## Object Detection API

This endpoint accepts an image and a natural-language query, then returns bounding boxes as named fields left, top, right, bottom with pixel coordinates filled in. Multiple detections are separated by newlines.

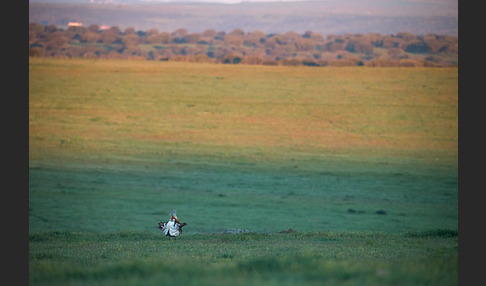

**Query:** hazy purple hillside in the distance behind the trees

left=29, top=0, right=458, bottom=36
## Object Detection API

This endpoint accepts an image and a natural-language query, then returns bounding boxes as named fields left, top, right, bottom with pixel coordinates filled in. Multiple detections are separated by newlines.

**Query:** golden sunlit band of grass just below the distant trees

left=29, top=59, right=458, bottom=162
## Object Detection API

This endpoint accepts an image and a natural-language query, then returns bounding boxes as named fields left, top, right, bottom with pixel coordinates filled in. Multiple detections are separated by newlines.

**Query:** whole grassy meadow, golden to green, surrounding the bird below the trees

left=29, top=58, right=458, bottom=285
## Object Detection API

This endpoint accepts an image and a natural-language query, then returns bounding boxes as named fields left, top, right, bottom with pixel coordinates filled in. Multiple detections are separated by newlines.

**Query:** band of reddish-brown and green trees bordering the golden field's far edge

left=29, top=23, right=458, bottom=67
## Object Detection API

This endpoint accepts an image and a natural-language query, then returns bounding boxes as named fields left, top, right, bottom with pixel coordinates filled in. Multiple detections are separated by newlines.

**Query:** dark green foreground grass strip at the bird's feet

left=29, top=230, right=457, bottom=285
